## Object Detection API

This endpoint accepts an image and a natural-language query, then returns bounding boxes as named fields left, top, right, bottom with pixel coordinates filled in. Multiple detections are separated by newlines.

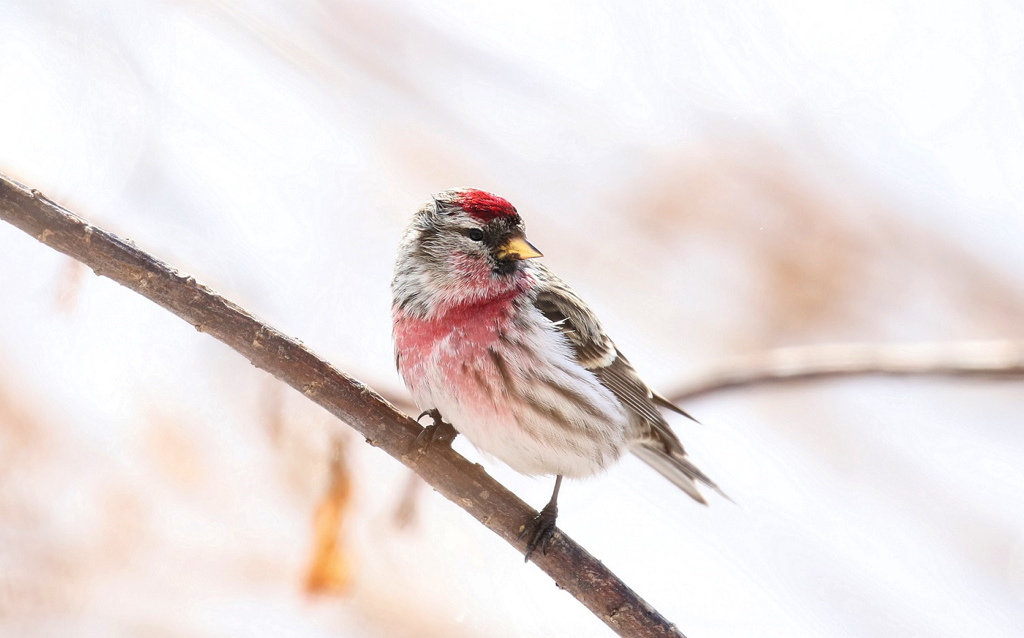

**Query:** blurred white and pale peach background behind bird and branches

left=0, top=0, right=1024, bottom=638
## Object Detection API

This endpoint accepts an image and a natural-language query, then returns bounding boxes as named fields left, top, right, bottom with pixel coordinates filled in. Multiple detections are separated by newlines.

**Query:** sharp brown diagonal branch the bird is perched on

left=0, top=175, right=682, bottom=638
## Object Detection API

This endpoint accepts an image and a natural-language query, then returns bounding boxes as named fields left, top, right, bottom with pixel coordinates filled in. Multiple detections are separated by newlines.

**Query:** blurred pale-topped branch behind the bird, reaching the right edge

left=669, top=340, right=1024, bottom=401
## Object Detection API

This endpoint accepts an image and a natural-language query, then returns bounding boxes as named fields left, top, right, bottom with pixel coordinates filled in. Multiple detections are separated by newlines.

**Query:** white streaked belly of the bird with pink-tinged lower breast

left=414, top=327, right=629, bottom=477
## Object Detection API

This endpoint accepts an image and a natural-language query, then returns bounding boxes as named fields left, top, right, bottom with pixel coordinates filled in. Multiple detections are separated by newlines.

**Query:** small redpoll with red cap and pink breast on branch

left=391, top=188, right=718, bottom=559
